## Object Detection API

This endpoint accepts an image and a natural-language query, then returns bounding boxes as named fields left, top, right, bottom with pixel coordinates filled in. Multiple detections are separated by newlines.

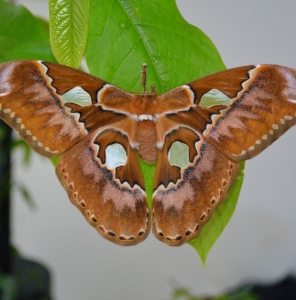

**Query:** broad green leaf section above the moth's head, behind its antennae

left=86, top=0, right=225, bottom=93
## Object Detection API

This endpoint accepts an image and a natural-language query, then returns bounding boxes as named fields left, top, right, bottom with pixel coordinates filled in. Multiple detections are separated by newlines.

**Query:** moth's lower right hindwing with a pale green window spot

left=152, top=123, right=239, bottom=246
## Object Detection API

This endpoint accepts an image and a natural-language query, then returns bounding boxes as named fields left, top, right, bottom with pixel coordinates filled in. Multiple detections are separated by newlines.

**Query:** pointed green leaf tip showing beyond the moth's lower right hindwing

left=189, top=162, right=245, bottom=265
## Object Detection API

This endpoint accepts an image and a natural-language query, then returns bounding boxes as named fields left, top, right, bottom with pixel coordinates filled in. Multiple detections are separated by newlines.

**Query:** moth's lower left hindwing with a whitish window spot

left=56, top=129, right=150, bottom=246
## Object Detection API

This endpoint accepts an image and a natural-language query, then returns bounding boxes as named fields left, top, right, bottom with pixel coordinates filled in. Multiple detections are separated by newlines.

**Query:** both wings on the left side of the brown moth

left=0, top=61, right=150, bottom=245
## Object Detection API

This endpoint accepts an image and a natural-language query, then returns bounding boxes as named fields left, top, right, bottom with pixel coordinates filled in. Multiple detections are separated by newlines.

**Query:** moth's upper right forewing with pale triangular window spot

left=189, top=65, right=296, bottom=161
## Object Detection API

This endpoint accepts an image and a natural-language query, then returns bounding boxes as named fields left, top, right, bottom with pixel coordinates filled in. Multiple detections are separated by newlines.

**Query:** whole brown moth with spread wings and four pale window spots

left=0, top=61, right=296, bottom=246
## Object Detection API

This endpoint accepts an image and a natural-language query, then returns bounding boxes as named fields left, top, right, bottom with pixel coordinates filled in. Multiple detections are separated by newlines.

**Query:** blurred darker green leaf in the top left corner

left=0, top=0, right=55, bottom=63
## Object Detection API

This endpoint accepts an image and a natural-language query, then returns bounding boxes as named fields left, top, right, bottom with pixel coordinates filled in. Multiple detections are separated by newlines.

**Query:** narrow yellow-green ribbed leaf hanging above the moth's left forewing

left=49, top=0, right=89, bottom=68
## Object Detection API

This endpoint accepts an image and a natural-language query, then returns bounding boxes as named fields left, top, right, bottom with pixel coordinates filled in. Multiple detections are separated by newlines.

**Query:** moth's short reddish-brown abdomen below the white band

left=137, top=120, right=157, bottom=163
